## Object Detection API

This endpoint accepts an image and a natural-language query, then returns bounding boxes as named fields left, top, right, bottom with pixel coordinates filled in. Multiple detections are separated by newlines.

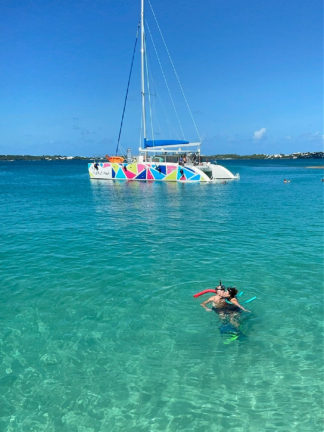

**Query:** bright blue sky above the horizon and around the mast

left=0, top=0, right=323, bottom=156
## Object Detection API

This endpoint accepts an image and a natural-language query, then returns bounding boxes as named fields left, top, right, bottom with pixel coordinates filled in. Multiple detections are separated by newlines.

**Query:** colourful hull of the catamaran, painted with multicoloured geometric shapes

left=88, top=162, right=239, bottom=183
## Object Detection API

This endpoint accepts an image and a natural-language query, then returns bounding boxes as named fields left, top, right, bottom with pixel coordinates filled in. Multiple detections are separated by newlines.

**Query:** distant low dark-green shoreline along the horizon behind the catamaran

left=0, top=152, right=324, bottom=161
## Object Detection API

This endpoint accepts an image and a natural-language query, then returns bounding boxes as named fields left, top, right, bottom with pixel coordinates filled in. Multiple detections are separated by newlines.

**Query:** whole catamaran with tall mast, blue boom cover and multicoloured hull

left=88, top=0, right=239, bottom=183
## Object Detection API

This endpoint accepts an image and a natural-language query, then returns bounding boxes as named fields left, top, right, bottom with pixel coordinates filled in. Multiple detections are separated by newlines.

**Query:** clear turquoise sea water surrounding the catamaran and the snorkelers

left=0, top=160, right=323, bottom=432
